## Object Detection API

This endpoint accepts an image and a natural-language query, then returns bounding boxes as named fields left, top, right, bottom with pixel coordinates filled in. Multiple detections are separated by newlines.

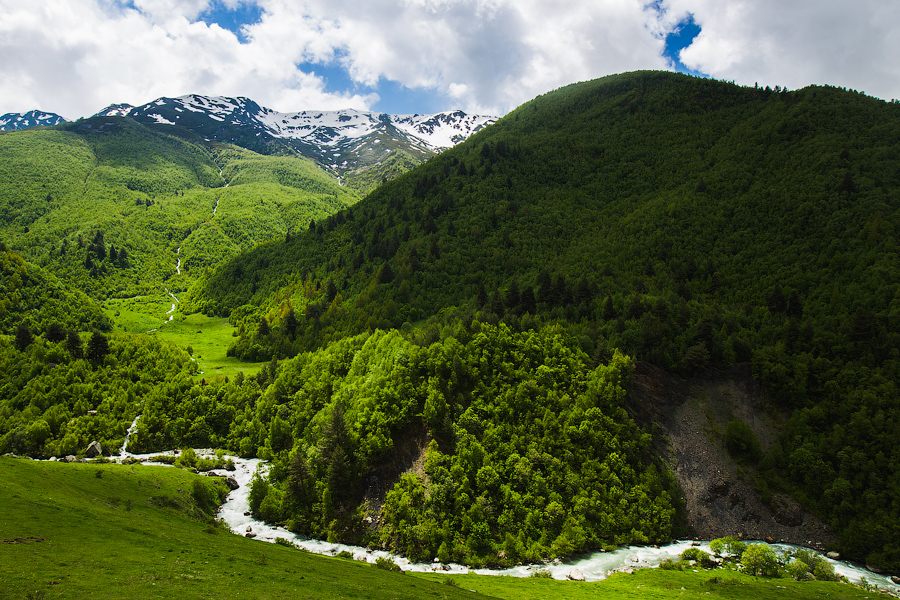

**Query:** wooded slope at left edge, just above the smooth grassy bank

left=0, top=322, right=197, bottom=458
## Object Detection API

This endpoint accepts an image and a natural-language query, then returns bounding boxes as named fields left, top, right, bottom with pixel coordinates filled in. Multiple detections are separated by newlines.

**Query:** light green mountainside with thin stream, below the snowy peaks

left=0, top=117, right=358, bottom=298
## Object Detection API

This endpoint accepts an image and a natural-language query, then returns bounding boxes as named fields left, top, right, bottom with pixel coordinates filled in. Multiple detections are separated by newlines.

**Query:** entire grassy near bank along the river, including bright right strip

left=0, top=457, right=886, bottom=600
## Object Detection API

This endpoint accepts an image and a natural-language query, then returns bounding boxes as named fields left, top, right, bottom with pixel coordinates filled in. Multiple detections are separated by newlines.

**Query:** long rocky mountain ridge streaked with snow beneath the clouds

left=97, top=94, right=496, bottom=188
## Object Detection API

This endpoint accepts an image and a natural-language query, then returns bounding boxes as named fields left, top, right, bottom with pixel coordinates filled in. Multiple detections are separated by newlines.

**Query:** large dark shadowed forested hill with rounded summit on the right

left=194, top=72, right=900, bottom=568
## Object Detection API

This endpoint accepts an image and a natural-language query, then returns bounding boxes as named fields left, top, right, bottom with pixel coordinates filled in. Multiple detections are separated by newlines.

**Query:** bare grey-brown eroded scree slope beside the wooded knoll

left=628, top=362, right=836, bottom=548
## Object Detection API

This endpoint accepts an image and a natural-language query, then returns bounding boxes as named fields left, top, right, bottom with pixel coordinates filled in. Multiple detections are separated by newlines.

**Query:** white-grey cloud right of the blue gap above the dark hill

left=665, top=0, right=900, bottom=99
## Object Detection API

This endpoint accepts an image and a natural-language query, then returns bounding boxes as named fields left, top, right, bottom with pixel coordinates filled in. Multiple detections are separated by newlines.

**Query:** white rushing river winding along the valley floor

left=105, top=448, right=900, bottom=597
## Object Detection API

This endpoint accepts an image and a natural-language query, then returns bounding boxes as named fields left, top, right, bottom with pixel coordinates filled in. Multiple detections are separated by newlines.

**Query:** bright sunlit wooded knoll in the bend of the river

left=98, top=321, right=676, bottom=564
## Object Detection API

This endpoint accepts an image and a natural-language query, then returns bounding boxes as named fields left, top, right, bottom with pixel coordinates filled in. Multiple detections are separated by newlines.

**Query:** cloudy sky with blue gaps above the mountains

left=0, top=0, right=900, bottom=119
